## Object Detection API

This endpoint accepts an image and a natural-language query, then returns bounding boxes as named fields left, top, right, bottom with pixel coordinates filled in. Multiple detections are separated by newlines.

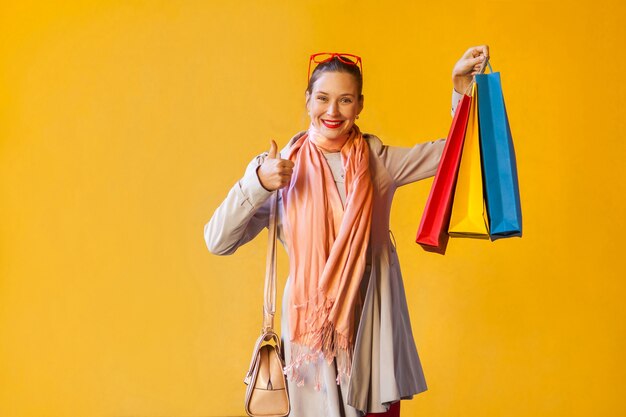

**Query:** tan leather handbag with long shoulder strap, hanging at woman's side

left=243, top=192, right=290, bottom=417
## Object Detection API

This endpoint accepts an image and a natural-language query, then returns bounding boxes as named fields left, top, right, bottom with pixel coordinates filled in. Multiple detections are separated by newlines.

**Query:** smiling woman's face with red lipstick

left=306, top=72, right=363, bottom=140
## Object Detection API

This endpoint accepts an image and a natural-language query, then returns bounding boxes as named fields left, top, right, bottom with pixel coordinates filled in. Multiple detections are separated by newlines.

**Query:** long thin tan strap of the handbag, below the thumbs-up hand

left=262, top=191, right=278, bottom=333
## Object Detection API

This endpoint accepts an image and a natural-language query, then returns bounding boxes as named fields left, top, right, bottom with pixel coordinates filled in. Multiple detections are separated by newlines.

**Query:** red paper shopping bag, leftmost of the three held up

left=415, top=95, right=472, bottom=253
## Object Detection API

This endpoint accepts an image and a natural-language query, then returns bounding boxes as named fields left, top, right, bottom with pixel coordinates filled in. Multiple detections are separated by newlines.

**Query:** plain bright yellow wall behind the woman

left=0, top=0, right=626, bottom=417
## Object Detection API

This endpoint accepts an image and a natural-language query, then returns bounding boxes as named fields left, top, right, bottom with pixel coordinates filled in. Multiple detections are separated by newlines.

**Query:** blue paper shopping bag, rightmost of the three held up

left=476, top=65, right=522, bottom=240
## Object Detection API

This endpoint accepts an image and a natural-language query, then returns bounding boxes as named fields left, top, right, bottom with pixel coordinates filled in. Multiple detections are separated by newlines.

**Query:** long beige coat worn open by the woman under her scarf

left=204, top=132, right=445, bottom=412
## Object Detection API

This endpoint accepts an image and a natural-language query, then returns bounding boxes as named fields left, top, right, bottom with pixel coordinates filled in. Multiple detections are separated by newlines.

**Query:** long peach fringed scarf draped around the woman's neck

left=283, top=125, right=373, bottom=389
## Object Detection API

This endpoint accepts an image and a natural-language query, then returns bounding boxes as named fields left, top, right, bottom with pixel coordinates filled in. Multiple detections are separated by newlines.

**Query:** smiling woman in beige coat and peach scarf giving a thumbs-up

left=204, top=45, right=489, bottom=417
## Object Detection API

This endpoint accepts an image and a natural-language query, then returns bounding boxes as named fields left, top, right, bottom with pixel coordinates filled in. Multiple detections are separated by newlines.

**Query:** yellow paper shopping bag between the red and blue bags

left=448, top=83, right=489, bottom=239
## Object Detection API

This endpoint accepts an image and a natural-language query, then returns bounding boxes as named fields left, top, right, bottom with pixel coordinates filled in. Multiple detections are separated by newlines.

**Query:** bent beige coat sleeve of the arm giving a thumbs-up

left=204, top=153, right=272, bottom=255
